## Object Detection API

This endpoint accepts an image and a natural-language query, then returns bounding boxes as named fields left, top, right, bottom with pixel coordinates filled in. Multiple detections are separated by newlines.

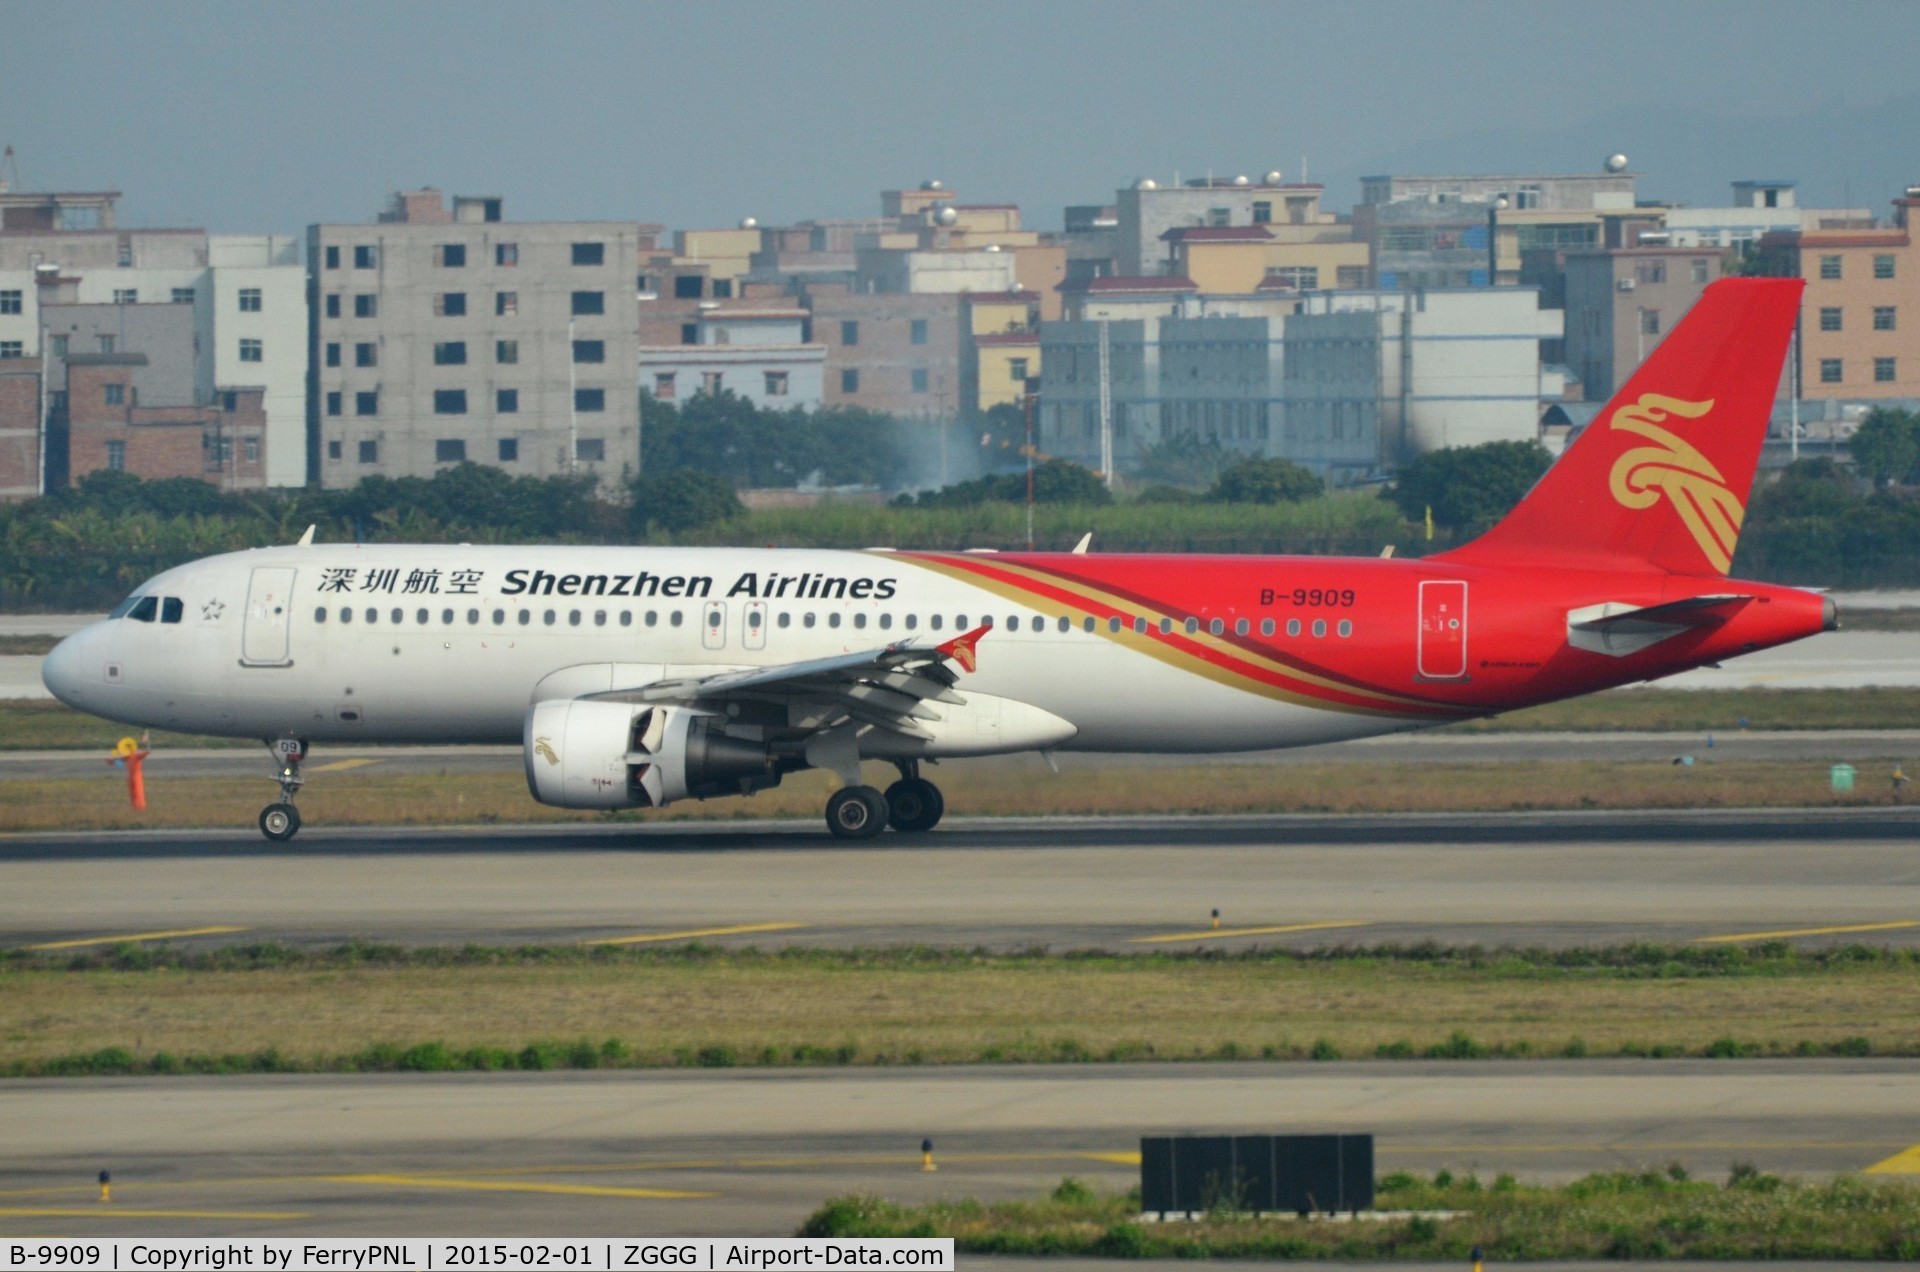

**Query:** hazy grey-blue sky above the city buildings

left=0, top=0, right=1920, bottom=232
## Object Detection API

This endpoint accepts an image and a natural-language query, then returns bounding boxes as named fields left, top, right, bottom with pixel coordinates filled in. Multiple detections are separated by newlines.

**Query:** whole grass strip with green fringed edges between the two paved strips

left=0, top=945, right=1920, bottom=1076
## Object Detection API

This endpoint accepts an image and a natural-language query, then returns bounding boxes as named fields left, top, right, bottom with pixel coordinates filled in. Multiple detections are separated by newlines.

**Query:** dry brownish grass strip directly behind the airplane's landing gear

left=0, top=761, right=1893, bottom=832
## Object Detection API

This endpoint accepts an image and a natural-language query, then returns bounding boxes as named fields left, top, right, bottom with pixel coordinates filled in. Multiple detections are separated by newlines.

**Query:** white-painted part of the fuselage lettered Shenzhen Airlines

left=44, top=546, right=1413, bottom=757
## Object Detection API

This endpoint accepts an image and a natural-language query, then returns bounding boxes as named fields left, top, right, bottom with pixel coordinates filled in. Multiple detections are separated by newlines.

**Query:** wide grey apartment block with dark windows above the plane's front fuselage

left=307, top=188, right=660, bottom=486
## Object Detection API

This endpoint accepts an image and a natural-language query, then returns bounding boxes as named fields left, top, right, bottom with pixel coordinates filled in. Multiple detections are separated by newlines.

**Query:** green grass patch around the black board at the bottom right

left=801, top=1164, right=1920, bottom=1262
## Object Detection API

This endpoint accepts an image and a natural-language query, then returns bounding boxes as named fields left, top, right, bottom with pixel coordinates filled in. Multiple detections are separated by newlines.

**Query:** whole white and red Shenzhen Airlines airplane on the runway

left=42, top=279, right=1837, bottom=840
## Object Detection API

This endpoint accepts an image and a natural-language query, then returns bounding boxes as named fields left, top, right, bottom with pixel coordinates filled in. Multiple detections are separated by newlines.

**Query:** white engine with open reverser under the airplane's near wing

left=524, top=697, right=780, bottom=809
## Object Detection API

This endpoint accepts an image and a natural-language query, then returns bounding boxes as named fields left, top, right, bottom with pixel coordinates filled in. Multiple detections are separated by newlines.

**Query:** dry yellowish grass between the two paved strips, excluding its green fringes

left=0, top=957, right=1920, bottom=1066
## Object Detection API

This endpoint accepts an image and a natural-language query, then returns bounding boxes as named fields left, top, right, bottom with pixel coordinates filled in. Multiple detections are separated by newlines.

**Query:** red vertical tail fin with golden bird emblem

left=1446, top=279, right=1805, bottom=575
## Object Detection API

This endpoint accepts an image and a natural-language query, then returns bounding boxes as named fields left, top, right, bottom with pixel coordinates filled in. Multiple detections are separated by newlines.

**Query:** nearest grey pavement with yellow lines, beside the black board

left=0, top=1061, right=1920, bottom=1235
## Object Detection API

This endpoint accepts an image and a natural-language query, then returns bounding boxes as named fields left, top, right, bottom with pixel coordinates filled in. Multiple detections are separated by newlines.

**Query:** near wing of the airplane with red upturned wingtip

left=589, top=626, right=991, bottom=740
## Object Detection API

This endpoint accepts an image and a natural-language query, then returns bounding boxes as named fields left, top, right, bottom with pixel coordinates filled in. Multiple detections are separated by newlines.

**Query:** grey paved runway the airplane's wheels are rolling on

left=0, top=809, right=1920, bottom=951
